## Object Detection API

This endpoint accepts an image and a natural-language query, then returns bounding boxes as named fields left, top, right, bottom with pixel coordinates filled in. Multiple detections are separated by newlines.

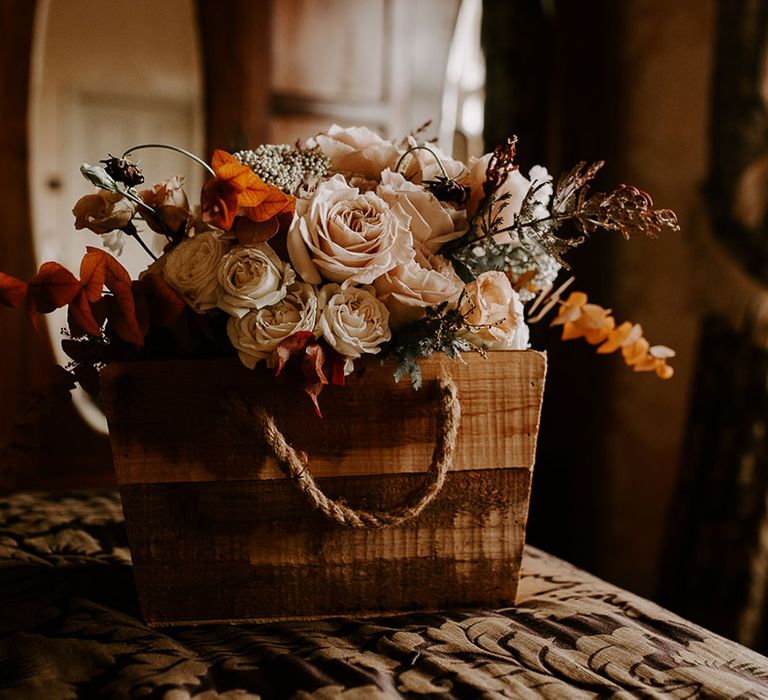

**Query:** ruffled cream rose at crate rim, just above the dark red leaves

left=227, top=282, right=319, bottom=369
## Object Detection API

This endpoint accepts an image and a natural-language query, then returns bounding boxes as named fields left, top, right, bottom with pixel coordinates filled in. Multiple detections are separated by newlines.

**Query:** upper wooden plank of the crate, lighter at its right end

left=101, top=350, right=546, bottom=484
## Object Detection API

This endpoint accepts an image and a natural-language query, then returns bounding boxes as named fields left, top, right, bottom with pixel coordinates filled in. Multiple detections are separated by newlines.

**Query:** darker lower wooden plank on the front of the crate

left=121, top=469, right=531, bottom=624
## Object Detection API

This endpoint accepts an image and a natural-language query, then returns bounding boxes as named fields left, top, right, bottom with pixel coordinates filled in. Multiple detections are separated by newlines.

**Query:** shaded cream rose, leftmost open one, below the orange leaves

left=162, top=230, right=232, bottom=313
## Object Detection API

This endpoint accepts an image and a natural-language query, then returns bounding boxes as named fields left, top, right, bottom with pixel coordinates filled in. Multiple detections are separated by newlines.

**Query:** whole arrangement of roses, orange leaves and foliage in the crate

left=0, top=126, right=678, bottom=413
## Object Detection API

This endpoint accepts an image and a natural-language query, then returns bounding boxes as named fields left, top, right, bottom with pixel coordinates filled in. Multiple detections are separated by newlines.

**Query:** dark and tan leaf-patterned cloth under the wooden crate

left=0, top=492, right=768, bottom=700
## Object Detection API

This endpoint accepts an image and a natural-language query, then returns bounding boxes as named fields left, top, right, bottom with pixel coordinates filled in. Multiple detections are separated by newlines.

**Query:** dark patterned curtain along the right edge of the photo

left=662, top=0, right=768, bottom=651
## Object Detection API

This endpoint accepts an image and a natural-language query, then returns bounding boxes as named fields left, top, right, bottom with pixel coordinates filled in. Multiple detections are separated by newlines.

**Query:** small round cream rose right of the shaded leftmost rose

left=217, top=243, right=296, bottom=317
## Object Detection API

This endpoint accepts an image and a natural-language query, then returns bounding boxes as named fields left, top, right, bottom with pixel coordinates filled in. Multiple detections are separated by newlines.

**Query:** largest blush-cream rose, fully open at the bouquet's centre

left=288, top=175, right=413, bottom=286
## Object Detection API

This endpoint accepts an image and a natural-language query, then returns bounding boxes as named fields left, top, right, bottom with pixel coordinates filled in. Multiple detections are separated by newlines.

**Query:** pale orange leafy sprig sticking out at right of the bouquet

left=552, top=292, right=675, bottom=379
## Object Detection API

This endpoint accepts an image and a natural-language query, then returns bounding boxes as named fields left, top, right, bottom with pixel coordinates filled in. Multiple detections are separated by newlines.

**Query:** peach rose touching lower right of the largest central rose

left=374, top=255, right=464, bottom=327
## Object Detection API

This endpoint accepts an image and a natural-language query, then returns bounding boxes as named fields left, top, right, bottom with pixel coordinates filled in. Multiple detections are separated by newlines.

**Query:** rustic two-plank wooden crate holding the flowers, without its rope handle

left=101, top=351, right=546, bottom=625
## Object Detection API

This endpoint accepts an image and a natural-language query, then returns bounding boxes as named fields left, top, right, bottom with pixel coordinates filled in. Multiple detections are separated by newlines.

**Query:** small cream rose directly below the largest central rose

left=319, top=284, right=392, bottom=359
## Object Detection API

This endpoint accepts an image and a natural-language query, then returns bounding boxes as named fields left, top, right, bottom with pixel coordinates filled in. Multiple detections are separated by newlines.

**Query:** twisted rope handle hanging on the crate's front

left=226, top=377, right=461, bottom=529
